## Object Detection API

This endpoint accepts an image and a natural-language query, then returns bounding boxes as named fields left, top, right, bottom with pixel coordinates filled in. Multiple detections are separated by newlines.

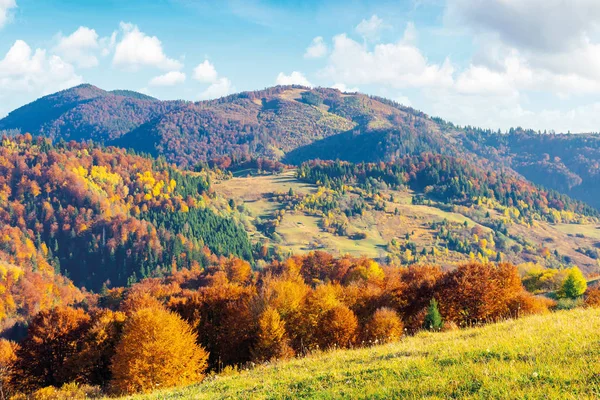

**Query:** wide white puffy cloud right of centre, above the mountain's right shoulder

left=321, top=34, right=454, bottom=88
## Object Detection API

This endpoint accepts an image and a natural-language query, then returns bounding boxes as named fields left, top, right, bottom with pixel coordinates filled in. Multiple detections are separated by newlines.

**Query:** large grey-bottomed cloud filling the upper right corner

left=445, top=0, right=600, bottom=96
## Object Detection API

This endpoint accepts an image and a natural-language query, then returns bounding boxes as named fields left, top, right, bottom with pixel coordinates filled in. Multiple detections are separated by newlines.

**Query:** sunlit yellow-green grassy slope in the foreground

left=122, top=309, right=600, bottom=400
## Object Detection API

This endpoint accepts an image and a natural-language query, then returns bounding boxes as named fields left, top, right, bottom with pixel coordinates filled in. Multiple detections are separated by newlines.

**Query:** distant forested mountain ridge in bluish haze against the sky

left=0, top=85, right=600, bottom=207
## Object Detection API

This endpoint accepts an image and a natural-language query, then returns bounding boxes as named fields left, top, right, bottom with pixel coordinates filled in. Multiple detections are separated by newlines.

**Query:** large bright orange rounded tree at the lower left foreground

left=111, top=308, right=208, bottom=393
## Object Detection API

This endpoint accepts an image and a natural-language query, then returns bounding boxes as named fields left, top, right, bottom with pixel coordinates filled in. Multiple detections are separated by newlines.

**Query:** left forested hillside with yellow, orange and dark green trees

left=0, top=135, right=252, bottom=291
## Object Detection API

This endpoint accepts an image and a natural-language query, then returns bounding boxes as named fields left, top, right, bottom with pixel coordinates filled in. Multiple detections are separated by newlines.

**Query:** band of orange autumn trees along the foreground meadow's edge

left=0, top=247, right=599, bottom=396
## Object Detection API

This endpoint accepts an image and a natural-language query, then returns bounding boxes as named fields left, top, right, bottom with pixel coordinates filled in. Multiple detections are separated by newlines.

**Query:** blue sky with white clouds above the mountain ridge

left=0, top=0, right=600, bottom=133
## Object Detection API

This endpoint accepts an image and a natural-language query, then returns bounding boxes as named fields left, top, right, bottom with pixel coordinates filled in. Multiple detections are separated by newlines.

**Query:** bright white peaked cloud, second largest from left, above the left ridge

left=113, top=22, right=183, bottom=71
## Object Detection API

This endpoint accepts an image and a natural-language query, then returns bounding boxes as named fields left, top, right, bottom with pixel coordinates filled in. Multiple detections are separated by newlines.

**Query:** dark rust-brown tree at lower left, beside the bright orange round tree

left=12, top=307, right=90, bottom=391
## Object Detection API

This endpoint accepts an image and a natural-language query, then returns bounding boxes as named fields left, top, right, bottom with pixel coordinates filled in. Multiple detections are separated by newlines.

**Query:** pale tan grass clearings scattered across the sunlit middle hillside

left=214, top=170, right=600, bottom=274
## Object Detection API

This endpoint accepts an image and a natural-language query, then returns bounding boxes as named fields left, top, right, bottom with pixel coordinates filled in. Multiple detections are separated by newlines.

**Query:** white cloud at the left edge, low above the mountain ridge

left=0, top=40, right=83, bottom=115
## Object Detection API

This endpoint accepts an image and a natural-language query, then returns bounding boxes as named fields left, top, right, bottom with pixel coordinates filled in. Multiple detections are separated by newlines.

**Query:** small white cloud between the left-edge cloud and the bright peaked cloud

left=54, top=26, right=100, bottom=68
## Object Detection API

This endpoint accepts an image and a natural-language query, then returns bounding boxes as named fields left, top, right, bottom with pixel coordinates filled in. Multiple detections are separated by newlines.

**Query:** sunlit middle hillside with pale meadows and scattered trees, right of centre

left=213, top=164, right=600, bottom=274
